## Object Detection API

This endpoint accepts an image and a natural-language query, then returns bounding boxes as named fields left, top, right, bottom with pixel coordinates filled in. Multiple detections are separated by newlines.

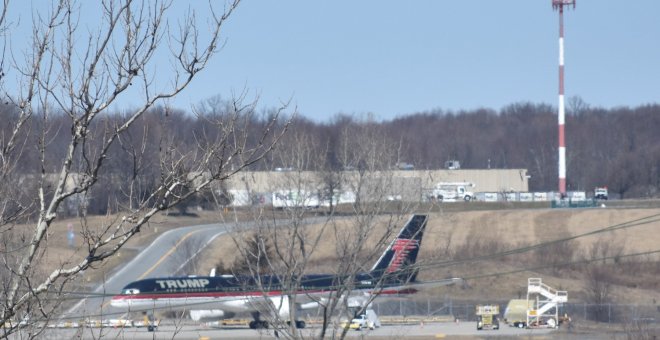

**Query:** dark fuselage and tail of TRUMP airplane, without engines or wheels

left=111, top=215, right=428, bottom=311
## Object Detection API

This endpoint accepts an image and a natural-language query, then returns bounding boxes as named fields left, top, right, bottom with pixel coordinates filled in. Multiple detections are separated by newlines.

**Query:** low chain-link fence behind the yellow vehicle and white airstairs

left=372, top=298, right=660, bottom=324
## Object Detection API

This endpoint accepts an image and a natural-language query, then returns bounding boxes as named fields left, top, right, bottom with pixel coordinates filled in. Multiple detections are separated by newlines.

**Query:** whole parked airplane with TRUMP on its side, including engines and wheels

left=111, top=214, right=460, bottom=329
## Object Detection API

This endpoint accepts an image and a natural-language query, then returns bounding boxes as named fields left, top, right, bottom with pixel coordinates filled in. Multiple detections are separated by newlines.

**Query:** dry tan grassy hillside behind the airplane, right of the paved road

left=200, top=208, right=660, bottom=304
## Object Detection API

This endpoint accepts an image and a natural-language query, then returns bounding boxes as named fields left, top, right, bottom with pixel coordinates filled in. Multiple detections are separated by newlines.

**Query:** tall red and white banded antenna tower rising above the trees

left=552, top=0, right=575, bottom=197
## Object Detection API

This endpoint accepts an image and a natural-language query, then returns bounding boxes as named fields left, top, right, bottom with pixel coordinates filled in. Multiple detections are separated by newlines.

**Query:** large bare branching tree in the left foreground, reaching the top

left=0, top=0, right=286, bottom=335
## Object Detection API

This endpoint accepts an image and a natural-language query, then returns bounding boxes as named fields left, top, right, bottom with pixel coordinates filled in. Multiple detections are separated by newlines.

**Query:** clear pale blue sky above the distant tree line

left=12, top=0, right=660, bottom=121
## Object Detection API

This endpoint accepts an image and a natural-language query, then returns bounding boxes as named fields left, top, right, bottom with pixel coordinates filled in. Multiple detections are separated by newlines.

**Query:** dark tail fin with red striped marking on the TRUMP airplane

left=371, top=215, right=428, bottom=283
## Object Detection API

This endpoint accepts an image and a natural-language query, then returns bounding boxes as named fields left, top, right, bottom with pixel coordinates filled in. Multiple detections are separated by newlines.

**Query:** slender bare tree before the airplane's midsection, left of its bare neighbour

left=248, top=129, right=331, bottom=338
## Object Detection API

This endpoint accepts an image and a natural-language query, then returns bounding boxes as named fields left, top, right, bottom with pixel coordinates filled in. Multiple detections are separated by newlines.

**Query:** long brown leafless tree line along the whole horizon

left=0, top=98, right=660, bottom=218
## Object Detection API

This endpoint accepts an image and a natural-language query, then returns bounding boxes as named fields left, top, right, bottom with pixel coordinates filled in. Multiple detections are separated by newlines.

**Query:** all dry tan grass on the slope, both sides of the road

left=25, top=201, right=660, bottom=303
